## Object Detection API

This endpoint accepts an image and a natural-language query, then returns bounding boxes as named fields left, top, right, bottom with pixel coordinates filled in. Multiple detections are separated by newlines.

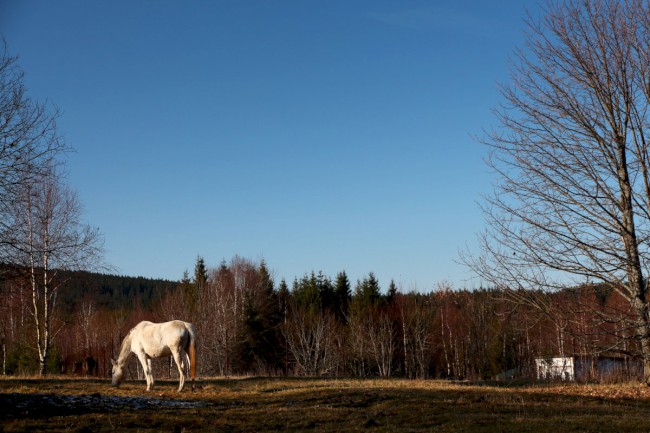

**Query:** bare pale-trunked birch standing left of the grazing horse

left=9, top=169, right=103, bottom=375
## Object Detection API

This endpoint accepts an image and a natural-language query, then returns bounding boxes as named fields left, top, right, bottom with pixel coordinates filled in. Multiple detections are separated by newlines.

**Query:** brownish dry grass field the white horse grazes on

left=0, top=378, right=650, bottom=433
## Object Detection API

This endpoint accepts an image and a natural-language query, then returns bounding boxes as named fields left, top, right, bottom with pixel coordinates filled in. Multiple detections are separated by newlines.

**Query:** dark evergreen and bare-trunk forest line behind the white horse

left=0, top=257, right=638, bottom=379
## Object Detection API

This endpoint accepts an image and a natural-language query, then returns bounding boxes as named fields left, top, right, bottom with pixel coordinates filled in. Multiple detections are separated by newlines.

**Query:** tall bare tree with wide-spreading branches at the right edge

left=468, top=0, right=650, bottom=385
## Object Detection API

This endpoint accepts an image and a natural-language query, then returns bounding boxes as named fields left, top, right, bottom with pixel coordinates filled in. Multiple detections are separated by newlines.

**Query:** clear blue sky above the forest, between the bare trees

left=0, top=0, right=538, bottom=291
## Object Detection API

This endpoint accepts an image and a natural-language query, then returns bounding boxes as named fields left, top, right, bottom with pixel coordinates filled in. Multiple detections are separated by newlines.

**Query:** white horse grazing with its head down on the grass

left=111, top=320, right=196, bottom=392
